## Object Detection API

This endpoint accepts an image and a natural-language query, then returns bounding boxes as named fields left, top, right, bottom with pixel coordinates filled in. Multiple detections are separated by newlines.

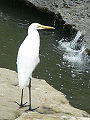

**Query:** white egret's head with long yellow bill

left=28, top=23, right=55, bottom=30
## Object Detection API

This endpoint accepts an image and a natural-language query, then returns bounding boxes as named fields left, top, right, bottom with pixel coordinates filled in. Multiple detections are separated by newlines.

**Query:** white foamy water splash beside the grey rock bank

left=58, top=31, right=89, bottom=70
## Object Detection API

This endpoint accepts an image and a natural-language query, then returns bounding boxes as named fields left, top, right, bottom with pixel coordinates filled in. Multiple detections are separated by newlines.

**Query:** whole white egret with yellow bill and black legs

left=17, top=23, right=54, bottom=111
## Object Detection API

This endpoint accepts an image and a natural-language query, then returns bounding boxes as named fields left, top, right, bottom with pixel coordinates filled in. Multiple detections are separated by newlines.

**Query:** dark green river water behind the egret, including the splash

left=0, top=0, right=90, bottom=114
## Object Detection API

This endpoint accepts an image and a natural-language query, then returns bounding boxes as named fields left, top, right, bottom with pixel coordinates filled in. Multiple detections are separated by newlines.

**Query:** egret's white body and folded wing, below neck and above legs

left=17, top=37, right=39, bottom=88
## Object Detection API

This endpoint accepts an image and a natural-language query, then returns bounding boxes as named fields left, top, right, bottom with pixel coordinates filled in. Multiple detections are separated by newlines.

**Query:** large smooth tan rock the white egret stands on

left=0, top=68, right=89, bottom=120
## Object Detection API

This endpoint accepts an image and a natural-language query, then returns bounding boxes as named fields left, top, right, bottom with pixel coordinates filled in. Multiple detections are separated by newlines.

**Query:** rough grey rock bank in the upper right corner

left=26, top=0, right=90, bottom=50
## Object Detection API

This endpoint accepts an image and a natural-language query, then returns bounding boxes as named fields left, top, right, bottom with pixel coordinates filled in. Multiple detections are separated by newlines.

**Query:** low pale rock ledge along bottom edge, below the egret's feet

left=16, top=112, right=90, bottom=120
